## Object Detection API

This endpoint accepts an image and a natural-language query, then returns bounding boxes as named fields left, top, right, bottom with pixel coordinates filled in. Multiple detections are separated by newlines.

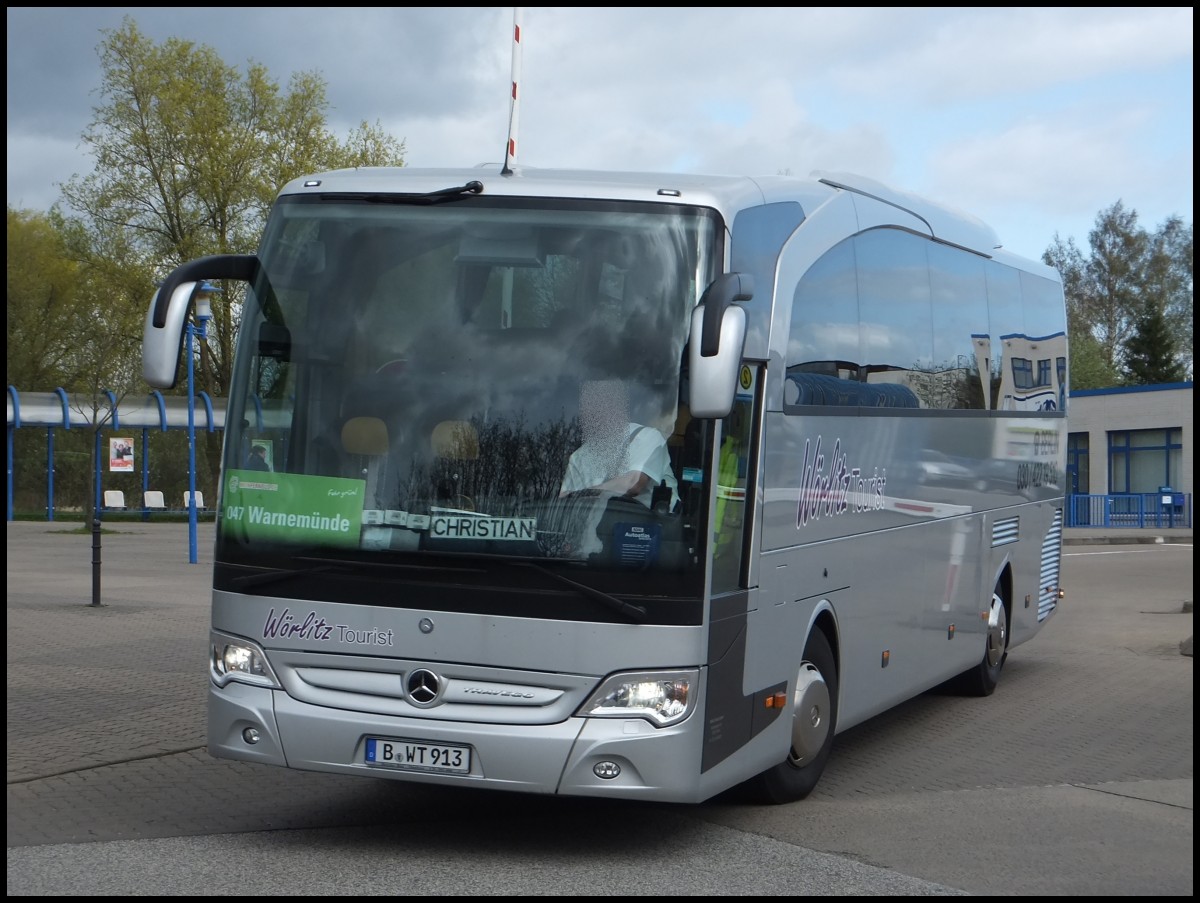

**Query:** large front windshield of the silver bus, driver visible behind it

left=217, top=190, right=721, bottom=600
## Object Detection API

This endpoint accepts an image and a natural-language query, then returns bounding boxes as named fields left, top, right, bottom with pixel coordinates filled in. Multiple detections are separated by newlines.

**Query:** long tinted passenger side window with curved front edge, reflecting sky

left=784, top=228, right=1067, bottom=412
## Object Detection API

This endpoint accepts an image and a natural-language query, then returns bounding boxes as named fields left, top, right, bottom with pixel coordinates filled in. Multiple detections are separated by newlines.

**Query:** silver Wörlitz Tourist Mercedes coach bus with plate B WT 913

left=144, top=168, right=1067, bottom=802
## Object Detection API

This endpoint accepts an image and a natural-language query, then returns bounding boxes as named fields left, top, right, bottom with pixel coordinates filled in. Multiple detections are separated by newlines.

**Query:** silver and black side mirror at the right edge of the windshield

left=688, top=273, right=754, bottom=418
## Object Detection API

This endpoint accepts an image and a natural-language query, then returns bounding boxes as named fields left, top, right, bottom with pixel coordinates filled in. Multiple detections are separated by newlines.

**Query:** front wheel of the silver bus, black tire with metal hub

left=748, top=629, right=838, bottom=805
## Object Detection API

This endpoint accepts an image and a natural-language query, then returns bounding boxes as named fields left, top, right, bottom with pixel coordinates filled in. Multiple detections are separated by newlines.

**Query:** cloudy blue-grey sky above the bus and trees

left=7, top=6, right=1193, bottom=257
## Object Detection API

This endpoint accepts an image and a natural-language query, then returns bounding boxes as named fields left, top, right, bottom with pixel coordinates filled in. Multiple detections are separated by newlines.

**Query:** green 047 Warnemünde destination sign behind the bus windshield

left=221, top=471, right=366, bottom=546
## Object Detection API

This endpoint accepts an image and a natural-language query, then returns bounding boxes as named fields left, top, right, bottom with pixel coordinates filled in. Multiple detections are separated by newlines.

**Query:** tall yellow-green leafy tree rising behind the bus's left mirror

left=62, top=17, right=404, bottom=501
